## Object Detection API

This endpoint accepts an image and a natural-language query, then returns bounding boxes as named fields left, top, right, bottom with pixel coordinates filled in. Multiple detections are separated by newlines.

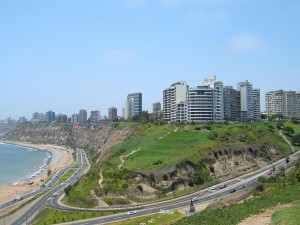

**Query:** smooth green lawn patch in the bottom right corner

left=272, top=203, right=300, bottom=225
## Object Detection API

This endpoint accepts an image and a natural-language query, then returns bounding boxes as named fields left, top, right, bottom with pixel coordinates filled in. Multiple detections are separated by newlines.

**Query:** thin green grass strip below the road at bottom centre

left=106, top=211, right=183, bottom=225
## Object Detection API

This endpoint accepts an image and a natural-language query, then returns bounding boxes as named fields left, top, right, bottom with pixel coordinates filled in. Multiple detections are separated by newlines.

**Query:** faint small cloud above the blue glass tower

left=104, top=50, right=136, bottom=64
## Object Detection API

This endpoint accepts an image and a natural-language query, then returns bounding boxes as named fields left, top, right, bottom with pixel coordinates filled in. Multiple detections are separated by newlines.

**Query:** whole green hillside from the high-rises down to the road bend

left=65, top=123, right=290, bottom=207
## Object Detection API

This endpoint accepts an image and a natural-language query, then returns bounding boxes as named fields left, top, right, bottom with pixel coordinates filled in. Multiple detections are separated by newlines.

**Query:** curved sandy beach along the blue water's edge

left=0, top=142, right=74, bottom=207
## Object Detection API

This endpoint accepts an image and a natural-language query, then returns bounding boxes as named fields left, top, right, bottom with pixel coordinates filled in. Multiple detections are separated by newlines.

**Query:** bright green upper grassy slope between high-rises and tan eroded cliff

left=104, top=124, right=289, bottom=171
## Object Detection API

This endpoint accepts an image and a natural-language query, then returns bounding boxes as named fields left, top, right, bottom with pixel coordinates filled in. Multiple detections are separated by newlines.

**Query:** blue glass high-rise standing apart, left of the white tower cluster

left=125, top=93, right=143, bottom=119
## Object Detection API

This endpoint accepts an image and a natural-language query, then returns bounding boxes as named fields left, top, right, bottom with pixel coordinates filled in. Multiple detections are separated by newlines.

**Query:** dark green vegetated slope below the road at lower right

left=176, top=156, right=300, bottom=225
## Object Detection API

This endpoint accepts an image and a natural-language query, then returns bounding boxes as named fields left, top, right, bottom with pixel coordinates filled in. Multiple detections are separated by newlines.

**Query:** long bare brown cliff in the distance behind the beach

left=2, top=124, right=133, bottom=160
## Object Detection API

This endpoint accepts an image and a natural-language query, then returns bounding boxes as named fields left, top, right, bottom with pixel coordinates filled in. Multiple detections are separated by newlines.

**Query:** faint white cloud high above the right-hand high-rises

left=226, top=33, right=267, bottom=53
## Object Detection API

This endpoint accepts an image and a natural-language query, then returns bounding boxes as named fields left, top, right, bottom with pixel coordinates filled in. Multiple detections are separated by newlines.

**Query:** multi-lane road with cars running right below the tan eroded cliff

left=46, top=149, right=300, bottom=225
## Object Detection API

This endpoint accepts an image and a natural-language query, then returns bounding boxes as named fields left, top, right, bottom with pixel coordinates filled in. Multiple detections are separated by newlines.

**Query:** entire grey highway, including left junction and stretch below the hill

left=2, top=134, right=300, bottom=225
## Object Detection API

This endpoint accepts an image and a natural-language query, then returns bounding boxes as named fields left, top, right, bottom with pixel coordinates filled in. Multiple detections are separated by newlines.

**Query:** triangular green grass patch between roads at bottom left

left=32, top=209, right=112, bottom=225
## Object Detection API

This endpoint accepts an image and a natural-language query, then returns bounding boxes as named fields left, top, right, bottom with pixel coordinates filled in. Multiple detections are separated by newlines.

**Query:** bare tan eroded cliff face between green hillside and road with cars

left=122, top=144, right=280, bottom=198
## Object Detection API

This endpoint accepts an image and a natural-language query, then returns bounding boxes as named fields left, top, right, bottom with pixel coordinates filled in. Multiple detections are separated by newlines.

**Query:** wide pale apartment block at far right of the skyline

left=265, top=90, right=300, bottom=118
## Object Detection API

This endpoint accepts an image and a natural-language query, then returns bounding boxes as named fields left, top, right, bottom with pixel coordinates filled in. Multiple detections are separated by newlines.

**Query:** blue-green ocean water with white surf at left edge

left=0, top=143, right=51, bottom=186
